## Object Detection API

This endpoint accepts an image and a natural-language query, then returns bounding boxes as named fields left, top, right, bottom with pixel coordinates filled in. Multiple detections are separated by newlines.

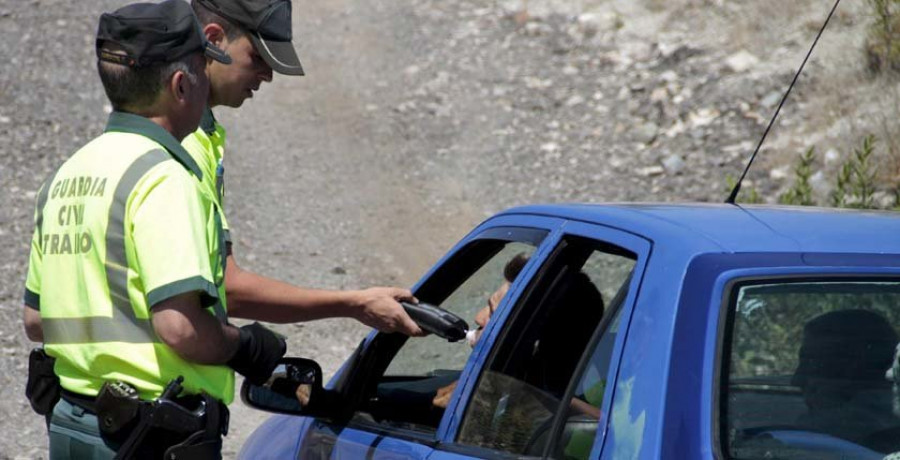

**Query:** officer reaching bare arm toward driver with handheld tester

left=183, top=0, right=422, bottom=336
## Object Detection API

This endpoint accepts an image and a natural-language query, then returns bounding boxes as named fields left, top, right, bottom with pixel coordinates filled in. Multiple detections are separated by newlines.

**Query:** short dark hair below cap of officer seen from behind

left=97, top=43, right=205, bottom=113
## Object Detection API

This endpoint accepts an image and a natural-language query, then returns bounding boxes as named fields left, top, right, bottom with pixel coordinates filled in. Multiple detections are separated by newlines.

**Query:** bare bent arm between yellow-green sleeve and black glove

left=151, top=292, right=240, bottom=364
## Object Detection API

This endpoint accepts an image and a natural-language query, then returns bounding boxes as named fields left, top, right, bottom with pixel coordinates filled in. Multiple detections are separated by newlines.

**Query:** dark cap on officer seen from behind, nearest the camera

left=96, top=0, right=231, bottom=67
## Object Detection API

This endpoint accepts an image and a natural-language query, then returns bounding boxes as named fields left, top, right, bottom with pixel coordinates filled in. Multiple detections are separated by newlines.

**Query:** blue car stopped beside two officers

left=240, top=204, right=900, bottom=460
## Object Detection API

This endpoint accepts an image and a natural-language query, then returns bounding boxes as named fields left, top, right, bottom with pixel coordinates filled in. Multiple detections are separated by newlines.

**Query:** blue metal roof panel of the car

left=501, top=203, right=900, bottom=254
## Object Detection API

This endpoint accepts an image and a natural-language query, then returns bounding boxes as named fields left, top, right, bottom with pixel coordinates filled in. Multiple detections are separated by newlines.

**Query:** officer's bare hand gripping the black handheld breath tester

left=355, top=287, right=425, bottom=337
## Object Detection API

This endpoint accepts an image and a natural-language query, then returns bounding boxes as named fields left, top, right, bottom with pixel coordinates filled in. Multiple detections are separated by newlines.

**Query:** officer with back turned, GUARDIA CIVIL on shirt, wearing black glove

left=24, top=0, right=285, bottom=458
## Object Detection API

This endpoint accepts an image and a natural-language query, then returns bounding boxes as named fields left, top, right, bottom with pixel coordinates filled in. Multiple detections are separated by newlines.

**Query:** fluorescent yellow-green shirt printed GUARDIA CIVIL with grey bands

left=25, top=112, right=234, bottom=403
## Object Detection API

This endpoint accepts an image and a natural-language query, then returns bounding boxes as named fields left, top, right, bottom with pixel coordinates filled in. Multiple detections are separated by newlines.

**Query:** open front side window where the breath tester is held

left=354, top=229, right=546, bottom=436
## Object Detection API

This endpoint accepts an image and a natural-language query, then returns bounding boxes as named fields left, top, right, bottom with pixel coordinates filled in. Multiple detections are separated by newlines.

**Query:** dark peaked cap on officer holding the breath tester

left=196, top=0, right=304, bottom=75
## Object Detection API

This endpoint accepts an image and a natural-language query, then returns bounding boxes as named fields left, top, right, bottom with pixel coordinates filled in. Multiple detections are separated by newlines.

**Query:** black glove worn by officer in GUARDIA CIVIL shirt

left=228, top=323, right=287, bottom=385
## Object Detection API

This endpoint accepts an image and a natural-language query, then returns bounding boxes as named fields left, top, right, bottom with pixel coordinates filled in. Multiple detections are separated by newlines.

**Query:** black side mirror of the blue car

left=241, top=357, right=339, bottom=418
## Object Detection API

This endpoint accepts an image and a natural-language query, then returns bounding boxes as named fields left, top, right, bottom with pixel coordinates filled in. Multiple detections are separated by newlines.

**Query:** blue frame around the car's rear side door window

left=435, top=220, right=653, bottom=458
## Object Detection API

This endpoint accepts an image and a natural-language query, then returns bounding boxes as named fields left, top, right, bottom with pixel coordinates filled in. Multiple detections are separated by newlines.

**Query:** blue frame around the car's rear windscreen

left=701, top=264, right=900, bottom=460
